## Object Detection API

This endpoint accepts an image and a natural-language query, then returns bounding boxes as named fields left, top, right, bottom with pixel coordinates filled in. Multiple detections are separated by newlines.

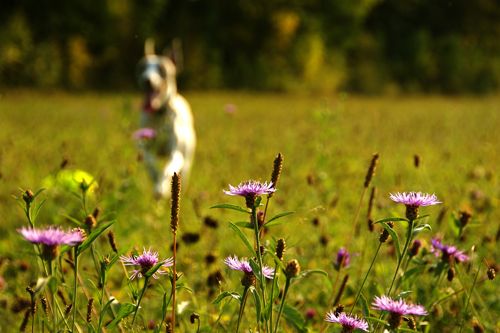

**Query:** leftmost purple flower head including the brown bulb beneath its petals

left=17, top=226, right=83, bottom=260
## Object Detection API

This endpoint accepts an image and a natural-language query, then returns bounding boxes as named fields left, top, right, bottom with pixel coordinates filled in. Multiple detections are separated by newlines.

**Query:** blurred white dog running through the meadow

left=134, top=39, right=196, bottom=197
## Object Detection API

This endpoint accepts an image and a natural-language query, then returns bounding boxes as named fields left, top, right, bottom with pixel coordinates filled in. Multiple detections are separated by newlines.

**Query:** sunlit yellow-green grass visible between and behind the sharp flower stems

left=0, top=91, right=500, bottom=332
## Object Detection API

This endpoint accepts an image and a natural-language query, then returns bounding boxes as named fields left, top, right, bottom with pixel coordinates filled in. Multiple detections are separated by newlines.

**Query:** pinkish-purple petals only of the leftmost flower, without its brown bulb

left=17, top=226, right=83, bottom=246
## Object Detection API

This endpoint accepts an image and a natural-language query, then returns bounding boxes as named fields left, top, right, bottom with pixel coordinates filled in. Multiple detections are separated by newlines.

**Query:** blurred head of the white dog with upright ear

left=137, top=39, right=181, bottom=114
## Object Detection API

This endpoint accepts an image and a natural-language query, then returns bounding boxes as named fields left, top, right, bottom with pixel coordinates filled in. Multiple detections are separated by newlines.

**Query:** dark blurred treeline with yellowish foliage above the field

left=0, top=0, right=500, bottom=94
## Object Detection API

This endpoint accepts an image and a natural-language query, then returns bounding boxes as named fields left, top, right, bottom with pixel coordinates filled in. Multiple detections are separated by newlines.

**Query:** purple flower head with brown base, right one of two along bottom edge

left=372, top=295, right=427, bottom=329
